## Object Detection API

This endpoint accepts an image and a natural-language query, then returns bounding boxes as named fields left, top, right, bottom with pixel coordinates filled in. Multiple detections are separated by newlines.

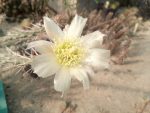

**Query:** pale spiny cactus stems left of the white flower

left=0, top=23, right=43, bottom=73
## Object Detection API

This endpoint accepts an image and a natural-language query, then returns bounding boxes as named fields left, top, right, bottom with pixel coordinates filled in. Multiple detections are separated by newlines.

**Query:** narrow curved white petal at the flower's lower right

left=70, top=67, right=90, bottom=89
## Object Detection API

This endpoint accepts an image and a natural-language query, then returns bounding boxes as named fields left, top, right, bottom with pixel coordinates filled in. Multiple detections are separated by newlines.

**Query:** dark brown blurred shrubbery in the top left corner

left=0, top=0, right=56, bottom=21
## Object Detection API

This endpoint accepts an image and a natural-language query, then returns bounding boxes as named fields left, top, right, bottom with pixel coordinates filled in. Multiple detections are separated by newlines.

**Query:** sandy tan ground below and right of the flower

left=0, top=19, right=150, bottom=113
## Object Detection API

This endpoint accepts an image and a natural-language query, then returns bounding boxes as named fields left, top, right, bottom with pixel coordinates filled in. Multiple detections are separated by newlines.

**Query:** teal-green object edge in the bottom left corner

left=0, top=81, right=8, bottom=113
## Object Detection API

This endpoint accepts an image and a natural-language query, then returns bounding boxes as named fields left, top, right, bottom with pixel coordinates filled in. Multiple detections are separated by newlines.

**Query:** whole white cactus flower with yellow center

left=28, top=15, right=110, bottom=92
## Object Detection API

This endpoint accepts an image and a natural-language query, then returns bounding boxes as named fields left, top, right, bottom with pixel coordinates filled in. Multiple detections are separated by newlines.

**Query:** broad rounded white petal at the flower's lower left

left=31, top=54, right=60, bottom=78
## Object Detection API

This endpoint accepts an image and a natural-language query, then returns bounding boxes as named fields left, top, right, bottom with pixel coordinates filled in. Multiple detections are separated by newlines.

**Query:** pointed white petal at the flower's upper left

left=44, top=17, right=64, bottom=41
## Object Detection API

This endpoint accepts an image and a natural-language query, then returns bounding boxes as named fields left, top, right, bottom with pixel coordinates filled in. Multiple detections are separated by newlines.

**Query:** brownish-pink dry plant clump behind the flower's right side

left=85, top=8, right=140, bottom=64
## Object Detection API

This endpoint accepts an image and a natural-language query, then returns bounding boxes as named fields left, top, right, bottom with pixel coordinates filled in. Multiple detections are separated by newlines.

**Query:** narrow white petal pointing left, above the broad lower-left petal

left=27, top=40, right=53, bottom=54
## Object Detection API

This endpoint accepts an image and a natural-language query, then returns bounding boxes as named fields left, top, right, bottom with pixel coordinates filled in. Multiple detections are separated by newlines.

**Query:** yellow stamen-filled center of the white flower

left=54, top=40, right=84, bottom=67
